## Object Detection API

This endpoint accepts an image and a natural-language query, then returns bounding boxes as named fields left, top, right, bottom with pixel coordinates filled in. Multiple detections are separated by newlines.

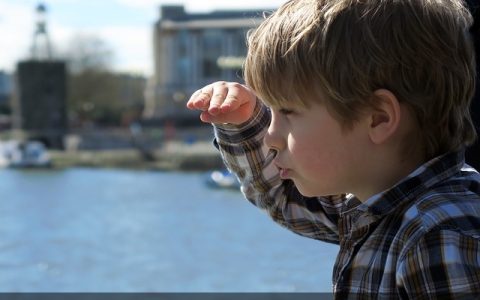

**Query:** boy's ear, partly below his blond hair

left=368, top=89, right=402, bottom=144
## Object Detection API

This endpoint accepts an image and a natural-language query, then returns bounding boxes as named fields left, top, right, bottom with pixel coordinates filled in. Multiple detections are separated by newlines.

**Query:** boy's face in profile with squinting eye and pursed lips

left=265, top=104, right=368, bottom=196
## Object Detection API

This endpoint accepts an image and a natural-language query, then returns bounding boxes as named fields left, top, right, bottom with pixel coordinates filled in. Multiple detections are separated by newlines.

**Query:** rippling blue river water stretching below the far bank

left=0, top=168, right=338, bottom=292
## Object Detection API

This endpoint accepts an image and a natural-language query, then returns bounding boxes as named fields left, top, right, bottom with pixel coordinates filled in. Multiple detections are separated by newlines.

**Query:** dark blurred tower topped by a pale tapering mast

left=12, top=3, right=68, bottom=149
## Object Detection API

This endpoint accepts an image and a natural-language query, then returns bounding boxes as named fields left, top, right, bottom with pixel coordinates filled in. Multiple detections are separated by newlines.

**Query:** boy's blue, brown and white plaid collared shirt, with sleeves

left=214, top=103, right=480, bottom=299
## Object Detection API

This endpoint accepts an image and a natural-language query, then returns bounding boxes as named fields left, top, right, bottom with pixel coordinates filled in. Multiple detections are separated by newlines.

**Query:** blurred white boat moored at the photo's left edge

left=0, top=140, right=52, bottom=168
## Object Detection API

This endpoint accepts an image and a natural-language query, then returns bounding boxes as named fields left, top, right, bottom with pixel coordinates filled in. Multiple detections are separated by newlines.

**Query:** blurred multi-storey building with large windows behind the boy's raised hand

left=144, top=5, right=272, bottom=122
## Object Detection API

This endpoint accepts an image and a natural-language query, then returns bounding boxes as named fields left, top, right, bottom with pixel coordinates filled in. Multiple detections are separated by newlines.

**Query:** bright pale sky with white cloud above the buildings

left=0, top=0, right=285, bottom=76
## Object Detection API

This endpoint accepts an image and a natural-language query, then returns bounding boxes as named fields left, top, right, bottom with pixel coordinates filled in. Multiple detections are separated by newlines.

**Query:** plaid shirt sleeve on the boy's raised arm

left=214, top=101, right=344, bottom=244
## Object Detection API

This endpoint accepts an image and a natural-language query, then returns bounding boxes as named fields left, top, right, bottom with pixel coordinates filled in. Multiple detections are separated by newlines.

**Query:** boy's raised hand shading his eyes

left=187, top=81, right=257, bottom=125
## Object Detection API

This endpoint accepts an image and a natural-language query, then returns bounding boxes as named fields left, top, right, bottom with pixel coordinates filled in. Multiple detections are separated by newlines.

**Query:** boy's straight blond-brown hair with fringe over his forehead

left=244, top=0, right=476, bottom=157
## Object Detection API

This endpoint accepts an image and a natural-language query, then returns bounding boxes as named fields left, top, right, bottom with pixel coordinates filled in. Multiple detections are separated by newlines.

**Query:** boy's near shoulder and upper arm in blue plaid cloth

left=396, top=171, right=480, bottom=299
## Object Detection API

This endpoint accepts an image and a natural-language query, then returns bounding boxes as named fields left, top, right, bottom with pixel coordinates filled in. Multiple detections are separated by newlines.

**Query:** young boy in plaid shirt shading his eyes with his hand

left=187, top=0, right=480, bottom=299
